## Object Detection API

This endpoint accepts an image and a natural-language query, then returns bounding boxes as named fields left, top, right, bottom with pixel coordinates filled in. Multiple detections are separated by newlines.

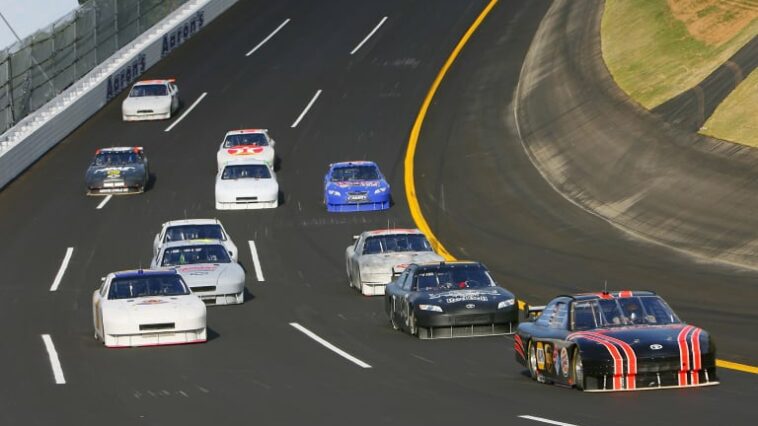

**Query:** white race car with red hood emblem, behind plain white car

left=216, top=129, right=276, bottom=170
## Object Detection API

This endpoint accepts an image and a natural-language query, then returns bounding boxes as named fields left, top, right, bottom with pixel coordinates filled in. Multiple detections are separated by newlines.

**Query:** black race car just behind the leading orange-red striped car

left=384, top=261, right=519, bottom=339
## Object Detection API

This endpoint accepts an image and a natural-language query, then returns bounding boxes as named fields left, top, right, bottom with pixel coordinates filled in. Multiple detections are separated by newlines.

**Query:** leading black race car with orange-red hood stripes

left=513, top=291, right=718, bottom=392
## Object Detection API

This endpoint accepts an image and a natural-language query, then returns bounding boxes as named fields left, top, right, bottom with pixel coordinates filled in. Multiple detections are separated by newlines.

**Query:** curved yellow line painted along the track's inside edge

left=404, top=0, right=758, bottom=374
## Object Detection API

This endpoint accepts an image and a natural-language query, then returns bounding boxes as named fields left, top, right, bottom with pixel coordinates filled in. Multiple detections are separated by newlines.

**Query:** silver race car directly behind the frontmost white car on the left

left=150, top=240, right=245, bottom=305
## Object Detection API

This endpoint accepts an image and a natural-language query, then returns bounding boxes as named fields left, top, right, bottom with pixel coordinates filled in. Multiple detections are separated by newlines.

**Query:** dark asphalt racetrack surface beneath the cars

left=0, top=0, right=757, bottom=425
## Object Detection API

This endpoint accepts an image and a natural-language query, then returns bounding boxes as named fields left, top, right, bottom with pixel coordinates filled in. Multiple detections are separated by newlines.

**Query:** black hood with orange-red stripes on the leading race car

left=569, top=324, right=714, bottom=358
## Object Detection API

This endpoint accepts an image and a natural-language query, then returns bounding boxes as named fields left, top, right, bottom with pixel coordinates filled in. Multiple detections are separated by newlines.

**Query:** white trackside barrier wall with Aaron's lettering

left=0, top=0, right=238, bottom=189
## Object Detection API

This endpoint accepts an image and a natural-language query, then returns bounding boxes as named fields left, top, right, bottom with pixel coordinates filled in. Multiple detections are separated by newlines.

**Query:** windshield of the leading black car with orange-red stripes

left=572, top=296, right=681, bottom=330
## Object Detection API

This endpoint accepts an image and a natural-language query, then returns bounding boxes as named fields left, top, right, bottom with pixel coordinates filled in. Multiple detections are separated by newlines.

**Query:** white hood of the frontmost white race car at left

left=103, top=295, right=205, bottom=324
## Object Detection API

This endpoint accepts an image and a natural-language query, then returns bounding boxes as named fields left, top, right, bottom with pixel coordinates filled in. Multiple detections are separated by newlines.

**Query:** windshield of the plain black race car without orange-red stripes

left=413, top=265, right=495, bottom=291
